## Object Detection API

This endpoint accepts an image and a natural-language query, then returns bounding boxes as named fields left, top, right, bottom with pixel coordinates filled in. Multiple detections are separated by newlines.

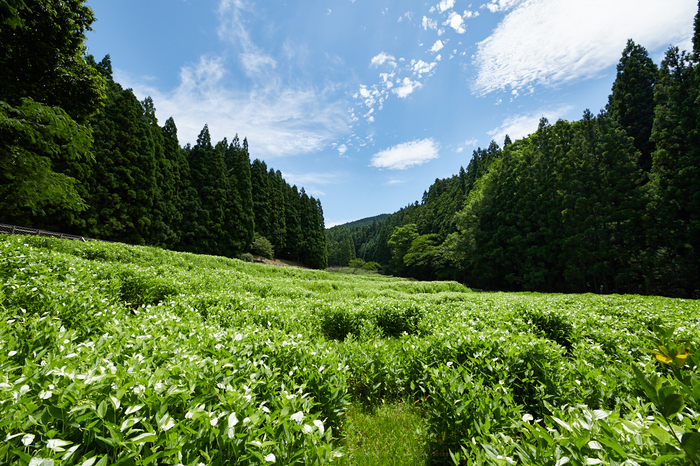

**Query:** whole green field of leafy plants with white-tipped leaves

left=0, top=235, right=700, bottom=466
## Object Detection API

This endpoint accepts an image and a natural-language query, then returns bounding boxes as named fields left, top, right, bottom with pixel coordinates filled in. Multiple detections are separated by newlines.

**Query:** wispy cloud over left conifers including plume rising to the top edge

left=119, top=0, right=349, bottom=158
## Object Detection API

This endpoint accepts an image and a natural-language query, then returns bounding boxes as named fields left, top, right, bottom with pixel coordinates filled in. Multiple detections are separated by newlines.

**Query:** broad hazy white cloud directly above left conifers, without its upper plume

left=120, top=58, right=348, bottom=158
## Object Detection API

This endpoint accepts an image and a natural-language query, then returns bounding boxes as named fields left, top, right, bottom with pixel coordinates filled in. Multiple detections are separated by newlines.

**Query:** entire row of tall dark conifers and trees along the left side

left=0, top=0, right=327, bottom=268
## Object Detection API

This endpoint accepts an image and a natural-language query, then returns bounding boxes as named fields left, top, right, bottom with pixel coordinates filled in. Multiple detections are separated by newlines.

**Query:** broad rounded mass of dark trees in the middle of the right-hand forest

left=457, top=112, right=643, bottom=291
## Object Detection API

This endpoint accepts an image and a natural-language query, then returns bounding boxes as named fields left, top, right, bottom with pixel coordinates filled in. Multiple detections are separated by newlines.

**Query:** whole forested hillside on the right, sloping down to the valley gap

left=327, top=10, right=700, bottom=297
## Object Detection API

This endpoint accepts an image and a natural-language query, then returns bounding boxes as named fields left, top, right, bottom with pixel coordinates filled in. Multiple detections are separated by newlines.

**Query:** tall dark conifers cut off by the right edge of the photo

left=649, top=45, right=700, bottom=297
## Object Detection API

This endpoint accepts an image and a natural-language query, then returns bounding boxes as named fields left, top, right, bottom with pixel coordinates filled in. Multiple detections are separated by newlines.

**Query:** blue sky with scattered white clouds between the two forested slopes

left=87, top=0, right=697, bottom=226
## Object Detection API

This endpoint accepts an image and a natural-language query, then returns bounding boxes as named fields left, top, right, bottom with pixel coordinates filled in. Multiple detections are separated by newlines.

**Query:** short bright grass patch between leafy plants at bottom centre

left=343, top=403, right=430, bottom=466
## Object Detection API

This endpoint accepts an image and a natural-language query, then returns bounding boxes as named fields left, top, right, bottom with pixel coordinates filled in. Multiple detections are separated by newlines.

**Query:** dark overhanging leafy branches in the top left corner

left=0, top=0, right=104, bottom=124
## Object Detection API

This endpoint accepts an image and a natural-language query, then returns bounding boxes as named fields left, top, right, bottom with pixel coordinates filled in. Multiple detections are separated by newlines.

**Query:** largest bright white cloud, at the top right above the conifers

left=473, top=0, right=697, bottom=94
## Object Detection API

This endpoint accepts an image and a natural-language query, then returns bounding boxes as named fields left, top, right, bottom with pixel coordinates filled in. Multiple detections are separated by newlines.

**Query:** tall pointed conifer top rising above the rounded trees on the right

left=606, top=40, right=658, bottom=172
